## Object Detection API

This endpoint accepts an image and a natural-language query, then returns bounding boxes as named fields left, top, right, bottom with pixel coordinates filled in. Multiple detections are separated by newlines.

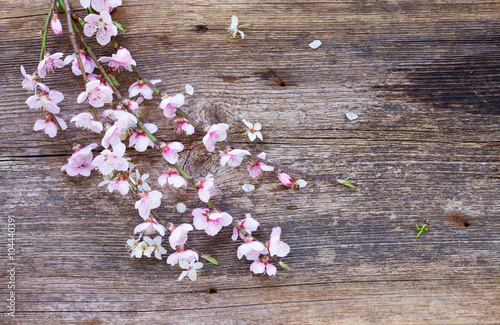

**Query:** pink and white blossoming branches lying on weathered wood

left=21, top=0, right=354, bottom=281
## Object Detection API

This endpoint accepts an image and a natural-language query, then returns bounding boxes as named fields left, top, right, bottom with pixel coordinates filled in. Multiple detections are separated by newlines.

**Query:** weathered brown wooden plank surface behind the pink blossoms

left=0, top=0, right=500, bottom=324
